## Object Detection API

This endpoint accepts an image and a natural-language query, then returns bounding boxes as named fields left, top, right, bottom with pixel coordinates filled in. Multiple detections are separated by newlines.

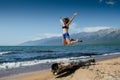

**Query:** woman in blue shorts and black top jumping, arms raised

left=60, top=13, right=82, bottom=46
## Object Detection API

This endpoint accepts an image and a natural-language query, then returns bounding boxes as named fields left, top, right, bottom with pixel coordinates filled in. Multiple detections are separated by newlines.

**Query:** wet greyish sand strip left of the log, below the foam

left=0, top=64, right=51, bottom=80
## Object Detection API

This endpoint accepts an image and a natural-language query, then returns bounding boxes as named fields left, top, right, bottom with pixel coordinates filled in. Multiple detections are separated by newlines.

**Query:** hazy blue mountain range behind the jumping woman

left=20, top=28, right=120, bottom=46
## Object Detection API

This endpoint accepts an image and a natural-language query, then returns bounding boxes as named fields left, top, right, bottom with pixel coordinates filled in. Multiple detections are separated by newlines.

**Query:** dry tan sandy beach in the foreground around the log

left=7, top=57, right=120, bottom=80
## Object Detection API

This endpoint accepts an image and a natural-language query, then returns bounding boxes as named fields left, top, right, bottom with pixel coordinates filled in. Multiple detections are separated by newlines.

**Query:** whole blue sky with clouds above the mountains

left=0, top=0, right=120, bottom=45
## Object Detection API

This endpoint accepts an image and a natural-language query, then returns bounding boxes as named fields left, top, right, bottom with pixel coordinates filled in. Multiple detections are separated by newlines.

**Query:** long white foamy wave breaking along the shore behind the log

left=0, top=56, right=88, bottom=70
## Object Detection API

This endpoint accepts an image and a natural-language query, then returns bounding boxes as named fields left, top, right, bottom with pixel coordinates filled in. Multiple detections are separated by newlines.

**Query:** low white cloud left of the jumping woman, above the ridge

left=31, top=33, right=61, bottom=41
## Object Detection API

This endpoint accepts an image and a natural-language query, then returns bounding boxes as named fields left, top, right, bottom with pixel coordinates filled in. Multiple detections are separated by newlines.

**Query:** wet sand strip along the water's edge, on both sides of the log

left=0, top=52, right=120, bottom=80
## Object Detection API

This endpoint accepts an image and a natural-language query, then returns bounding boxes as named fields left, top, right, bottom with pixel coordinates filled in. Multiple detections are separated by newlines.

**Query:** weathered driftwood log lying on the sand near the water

left=51, top=58, right=95, bottom=75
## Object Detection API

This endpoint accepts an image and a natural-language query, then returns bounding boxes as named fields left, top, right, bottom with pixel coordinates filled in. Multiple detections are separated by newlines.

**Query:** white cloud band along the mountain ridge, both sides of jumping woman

left=31, top=23, right=111, bottom=41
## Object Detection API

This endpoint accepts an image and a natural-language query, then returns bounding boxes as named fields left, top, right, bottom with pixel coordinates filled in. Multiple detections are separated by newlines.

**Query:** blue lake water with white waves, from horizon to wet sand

left=0, top=45, right=120, bottom=70
